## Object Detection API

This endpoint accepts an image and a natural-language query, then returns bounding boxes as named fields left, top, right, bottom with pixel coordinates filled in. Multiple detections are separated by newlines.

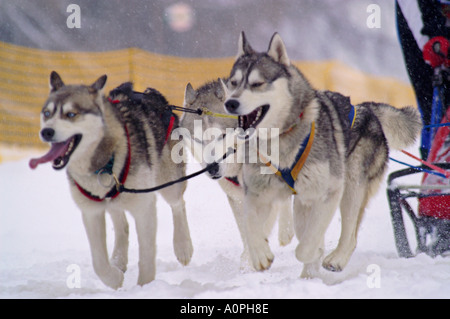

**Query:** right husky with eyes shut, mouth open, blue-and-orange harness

left=221, top=33, right=421, bottom=277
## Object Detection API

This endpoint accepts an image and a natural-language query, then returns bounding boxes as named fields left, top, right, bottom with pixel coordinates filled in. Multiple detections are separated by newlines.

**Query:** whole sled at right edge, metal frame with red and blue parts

left=387, top=65, right=450, bottom=258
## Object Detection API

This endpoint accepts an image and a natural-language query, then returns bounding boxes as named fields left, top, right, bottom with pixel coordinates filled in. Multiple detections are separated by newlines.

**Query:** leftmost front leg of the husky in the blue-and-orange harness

left=244, top=195, right=274, bottom=271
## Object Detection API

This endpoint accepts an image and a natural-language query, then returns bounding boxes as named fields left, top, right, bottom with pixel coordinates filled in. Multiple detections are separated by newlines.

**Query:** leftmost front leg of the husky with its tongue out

left=82, top=210, right=123, bottom=289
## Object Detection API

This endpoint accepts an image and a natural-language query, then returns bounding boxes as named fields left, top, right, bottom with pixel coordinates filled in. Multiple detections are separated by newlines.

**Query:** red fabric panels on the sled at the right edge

left=419, top=107, right=450, bottom=219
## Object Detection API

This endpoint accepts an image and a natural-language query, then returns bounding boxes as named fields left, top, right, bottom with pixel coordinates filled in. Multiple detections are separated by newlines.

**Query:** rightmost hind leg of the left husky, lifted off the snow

left=160, top=182, right=194, bottom=266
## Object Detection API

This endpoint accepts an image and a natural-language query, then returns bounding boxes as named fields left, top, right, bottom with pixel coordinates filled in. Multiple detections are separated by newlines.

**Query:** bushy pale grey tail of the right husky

left=362, top=103, right=422, bottom=150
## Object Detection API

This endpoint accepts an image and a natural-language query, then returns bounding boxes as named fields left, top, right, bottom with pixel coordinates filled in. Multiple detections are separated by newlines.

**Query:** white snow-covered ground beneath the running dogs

left=0, top=148, right=450, bottom=298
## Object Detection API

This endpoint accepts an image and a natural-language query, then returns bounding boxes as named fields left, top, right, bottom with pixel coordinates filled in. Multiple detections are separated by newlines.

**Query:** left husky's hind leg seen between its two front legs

left=109, top=210, right=129, bottom=272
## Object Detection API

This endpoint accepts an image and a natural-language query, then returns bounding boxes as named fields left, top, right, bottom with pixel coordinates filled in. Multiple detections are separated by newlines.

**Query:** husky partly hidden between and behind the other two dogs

left=180, top=79, right=294, bottom=266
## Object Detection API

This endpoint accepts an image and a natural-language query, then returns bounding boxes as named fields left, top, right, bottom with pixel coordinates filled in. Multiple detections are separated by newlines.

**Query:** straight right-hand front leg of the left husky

left=130, top=194, right=157, bottom=286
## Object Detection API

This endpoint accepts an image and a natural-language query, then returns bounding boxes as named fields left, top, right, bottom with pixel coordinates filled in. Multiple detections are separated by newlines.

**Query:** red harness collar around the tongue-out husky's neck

left=73, top=125, right=131, bottom=202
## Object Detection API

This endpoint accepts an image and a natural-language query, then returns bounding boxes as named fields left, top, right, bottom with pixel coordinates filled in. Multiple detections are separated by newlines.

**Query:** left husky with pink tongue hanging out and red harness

left=30, top=72, right=193, bottom=289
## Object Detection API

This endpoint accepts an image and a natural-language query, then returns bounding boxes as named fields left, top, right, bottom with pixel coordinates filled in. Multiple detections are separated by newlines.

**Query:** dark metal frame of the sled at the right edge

left=387, top=163, right=450, bottom=258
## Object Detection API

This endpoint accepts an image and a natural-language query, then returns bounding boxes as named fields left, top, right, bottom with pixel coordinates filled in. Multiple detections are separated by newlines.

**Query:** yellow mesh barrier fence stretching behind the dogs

left=0, top=42, right=415, bottom=147
